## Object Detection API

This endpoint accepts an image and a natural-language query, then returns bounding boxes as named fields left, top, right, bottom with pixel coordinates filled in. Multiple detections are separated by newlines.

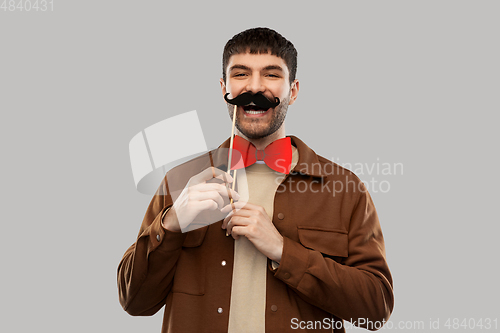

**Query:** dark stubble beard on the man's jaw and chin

left=226, top=94, right=290, bottom=139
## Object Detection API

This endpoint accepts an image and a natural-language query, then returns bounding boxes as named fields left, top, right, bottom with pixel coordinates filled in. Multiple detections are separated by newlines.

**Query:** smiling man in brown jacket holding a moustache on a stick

left=118, top=28, right=394, bottom=333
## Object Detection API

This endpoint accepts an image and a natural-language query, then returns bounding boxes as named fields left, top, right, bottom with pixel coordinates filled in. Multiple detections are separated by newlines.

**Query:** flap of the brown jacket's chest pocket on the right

left=297, top=226, right=349, bottom=258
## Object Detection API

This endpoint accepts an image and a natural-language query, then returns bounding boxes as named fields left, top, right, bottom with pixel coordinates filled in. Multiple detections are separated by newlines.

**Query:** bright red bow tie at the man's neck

left=231, top=135, right=292, bottom=174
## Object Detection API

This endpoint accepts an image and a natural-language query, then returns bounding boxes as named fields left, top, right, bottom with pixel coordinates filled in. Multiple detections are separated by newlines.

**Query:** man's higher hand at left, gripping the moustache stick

left=162, top=167, right=239, bottom=231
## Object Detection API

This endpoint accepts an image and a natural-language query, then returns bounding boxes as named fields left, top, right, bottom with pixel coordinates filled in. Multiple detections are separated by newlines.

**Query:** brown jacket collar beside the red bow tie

left=213, top=135, right=326, bottom=177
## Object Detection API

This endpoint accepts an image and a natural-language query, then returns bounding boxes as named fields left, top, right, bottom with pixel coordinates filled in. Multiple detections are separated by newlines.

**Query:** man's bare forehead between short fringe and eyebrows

left=227, top=52, right=288, bottom=73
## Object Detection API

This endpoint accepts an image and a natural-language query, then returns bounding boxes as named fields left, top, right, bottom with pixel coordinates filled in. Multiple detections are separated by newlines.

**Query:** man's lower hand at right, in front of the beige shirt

left=221, top=202, right=283, bottom=263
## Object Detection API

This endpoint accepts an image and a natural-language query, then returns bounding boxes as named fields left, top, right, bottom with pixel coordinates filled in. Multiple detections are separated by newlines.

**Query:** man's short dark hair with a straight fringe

left=222, top=28, right=297, bottom=83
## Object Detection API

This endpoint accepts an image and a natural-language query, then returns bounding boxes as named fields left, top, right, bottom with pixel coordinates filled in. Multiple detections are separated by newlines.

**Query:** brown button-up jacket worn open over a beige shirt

left=118, top=136, right=394, bottom=333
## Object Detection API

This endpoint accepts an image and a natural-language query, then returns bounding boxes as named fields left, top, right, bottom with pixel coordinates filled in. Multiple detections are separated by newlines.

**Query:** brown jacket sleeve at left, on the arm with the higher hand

left=118, top=181, right=186, bottom=316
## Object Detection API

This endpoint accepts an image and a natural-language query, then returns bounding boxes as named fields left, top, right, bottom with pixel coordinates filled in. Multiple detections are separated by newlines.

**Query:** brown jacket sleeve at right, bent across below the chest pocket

left=275, top=185, right=394, bottom=330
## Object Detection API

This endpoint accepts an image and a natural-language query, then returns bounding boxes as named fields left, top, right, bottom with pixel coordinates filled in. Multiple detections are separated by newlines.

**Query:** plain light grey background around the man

left=0, top=0, right=500, bottom=333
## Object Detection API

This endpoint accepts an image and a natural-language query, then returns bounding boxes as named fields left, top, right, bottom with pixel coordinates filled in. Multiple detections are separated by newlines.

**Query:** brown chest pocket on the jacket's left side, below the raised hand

left=172, top=227, right=208, bottom=296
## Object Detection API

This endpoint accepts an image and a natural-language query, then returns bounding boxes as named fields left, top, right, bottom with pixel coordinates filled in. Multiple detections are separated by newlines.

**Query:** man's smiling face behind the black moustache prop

left=221, top=53, right=298, bottom=139
